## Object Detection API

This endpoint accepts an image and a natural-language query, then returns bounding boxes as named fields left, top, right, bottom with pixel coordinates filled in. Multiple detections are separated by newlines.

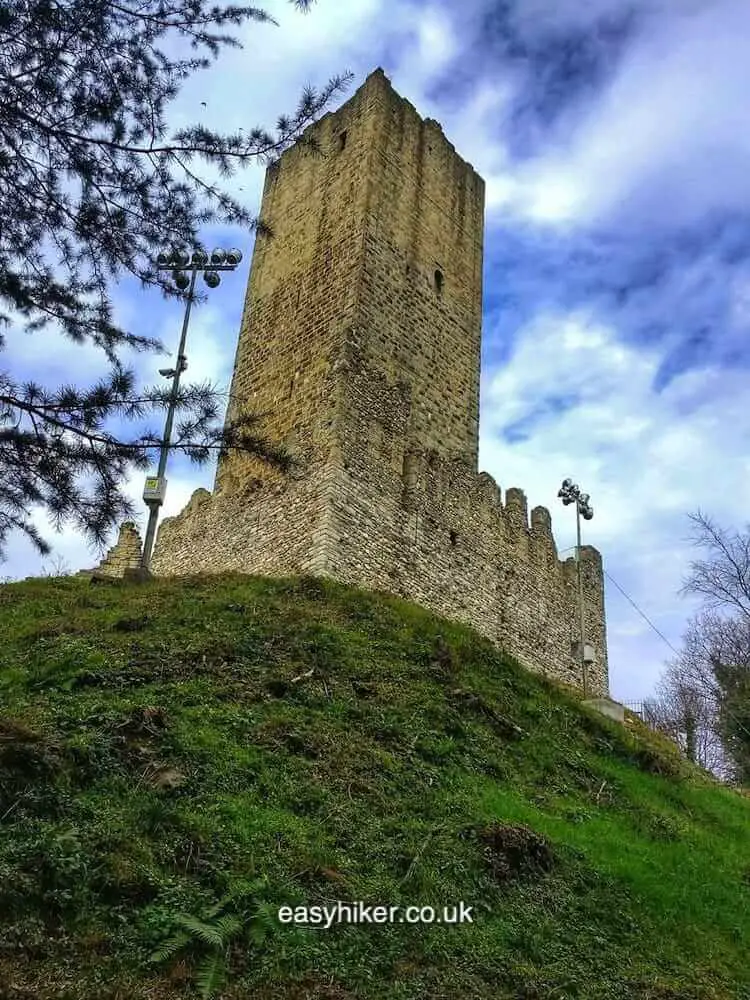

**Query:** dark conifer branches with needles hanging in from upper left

left=0, top=0, right=348, bottom=557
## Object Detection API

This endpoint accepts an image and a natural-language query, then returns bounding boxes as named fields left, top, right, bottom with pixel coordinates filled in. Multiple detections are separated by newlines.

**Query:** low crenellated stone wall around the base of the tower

left=153, top=455, right=608, bottom=694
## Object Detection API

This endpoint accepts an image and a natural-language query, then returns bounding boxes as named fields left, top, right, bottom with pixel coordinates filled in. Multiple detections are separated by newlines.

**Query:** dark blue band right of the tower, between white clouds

left=485, top=212, right=750, bottom=388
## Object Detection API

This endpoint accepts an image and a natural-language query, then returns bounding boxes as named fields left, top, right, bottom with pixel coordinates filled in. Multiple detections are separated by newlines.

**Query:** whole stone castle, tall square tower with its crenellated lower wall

left=152, top=69, right=608, bottom=695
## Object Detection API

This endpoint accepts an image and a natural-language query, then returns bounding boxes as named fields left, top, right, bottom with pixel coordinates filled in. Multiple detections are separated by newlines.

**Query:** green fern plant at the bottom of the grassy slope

left=151, top=894, right=273, bottom=1000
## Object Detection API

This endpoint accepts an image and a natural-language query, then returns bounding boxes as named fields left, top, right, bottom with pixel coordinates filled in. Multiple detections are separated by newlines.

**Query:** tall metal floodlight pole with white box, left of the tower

left=141, top=250, right=242, bottom=572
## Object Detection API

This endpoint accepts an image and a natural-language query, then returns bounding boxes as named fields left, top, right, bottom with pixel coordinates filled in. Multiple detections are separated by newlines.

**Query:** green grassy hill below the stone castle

left=0, top=576, right=750, bottom=1000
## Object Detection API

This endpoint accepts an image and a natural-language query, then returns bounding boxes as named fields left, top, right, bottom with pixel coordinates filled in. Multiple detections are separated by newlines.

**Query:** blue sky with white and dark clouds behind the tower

left=0, top=0, right=750, bottom=700
